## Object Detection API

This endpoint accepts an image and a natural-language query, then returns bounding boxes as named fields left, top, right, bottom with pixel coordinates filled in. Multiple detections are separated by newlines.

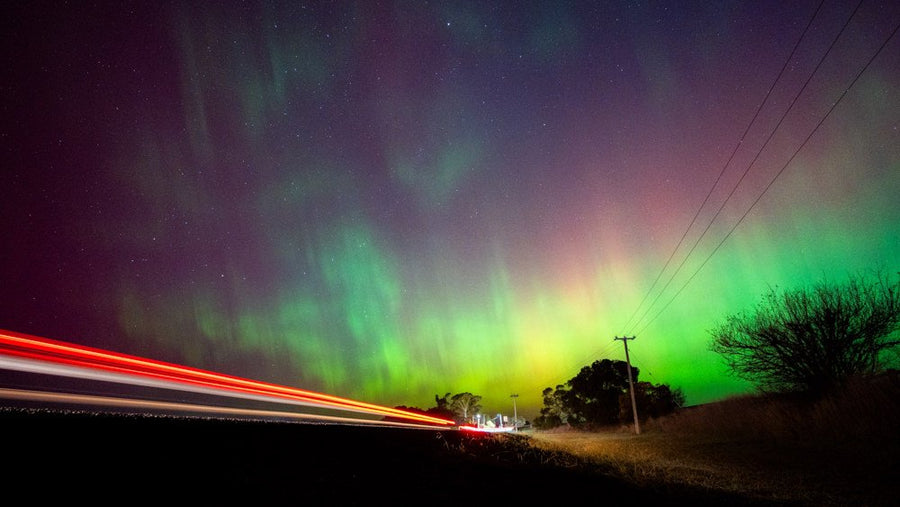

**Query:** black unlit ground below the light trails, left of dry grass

left=0, top=410, right=788, bottom=506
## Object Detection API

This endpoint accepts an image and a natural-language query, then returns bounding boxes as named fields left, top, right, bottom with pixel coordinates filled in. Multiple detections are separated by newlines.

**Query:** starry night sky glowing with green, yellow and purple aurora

left=0, top=0, right=900, bottom=417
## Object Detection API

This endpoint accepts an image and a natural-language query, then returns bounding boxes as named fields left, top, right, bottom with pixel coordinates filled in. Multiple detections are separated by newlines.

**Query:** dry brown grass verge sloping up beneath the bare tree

left=531, top=376, right=900, bottom=505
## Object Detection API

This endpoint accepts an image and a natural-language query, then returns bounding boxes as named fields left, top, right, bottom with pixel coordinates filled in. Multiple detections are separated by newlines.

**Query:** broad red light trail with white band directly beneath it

left=0, top=331, right=454, bottom=426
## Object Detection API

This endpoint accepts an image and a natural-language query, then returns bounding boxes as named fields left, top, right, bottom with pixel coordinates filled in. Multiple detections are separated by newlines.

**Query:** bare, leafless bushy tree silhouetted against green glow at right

left=710, top=273, right=900, bottom=395
